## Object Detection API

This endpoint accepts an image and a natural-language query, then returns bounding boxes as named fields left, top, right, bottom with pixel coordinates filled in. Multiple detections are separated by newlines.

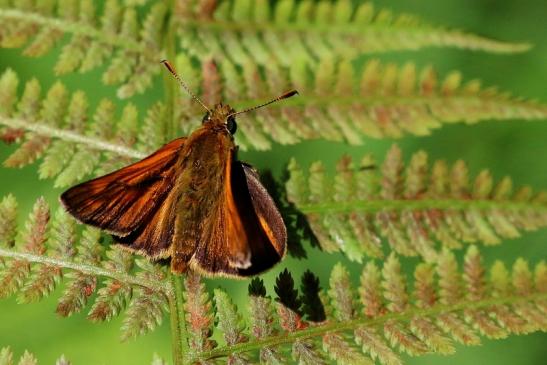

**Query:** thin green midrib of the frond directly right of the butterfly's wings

left=298, top=199, right=547, bottom=213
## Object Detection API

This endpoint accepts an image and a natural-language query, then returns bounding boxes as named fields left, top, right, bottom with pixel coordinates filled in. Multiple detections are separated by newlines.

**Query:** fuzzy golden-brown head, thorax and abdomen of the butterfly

left=168, top=104, right=237, bottom=271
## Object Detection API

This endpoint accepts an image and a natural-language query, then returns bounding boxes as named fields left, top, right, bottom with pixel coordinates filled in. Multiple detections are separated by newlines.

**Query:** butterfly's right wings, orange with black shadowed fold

left=190, top=161, right=287, bottom=278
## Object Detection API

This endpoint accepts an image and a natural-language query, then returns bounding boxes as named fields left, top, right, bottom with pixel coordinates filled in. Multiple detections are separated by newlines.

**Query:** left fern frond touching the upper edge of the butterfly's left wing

left=0, top=70, right=166, bottom=187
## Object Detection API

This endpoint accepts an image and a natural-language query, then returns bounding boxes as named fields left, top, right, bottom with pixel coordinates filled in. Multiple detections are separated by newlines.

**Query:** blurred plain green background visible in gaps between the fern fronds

left=0, top=0, right=547, bottom=365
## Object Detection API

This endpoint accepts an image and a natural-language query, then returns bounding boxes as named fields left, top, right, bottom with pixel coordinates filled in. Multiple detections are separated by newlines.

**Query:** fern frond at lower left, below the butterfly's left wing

left=0, top=195, right=171, bottom=339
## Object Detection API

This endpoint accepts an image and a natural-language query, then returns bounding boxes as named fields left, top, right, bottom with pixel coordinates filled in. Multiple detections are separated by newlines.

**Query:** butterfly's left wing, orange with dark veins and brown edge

left=61, top=138, right=186, bottom=236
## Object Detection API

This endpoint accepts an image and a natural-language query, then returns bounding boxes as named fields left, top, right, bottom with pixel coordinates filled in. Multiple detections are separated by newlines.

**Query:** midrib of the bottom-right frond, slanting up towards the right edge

left=189, top=293, right=547, bottom=363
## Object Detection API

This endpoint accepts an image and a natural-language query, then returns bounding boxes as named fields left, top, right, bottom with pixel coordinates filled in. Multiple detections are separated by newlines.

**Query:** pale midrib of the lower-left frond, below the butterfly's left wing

left=0, top=248, right=170, bottom=297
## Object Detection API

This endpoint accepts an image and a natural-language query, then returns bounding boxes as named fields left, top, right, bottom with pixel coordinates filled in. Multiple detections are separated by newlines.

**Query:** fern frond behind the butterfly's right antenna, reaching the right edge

left=171, top=54, right=547, bottom=150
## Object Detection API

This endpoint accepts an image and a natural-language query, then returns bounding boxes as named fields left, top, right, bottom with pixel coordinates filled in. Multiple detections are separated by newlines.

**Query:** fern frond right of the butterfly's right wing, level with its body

left=286, top=146, right=547, bottom=262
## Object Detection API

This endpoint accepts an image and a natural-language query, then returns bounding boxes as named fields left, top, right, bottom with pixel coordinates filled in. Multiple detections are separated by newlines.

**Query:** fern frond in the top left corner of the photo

left=0, top=0, right=166, bottom=98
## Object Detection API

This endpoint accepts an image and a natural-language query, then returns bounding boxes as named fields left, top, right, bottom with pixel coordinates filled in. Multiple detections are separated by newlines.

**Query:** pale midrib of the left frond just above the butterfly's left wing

left=0, top=118, right=146, bottom=159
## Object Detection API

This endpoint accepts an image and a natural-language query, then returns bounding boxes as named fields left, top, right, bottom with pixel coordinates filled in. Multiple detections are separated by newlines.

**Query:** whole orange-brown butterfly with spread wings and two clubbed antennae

left=61, top=61, right=297, bottom=278
